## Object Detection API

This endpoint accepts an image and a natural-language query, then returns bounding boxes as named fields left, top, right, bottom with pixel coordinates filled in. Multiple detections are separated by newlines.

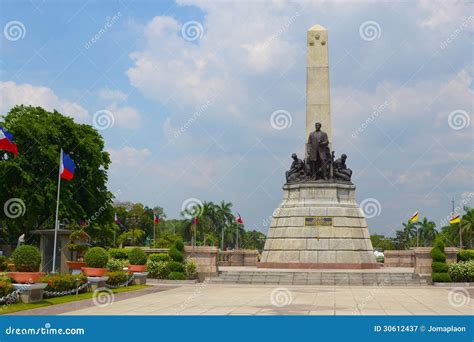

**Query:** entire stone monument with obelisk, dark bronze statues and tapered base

left=257, top=25, right=379, bottom=269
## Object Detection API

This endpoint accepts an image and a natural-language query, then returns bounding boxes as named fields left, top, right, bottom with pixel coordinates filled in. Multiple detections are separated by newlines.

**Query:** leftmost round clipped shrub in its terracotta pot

left=8, top=245, right=44, bottom=284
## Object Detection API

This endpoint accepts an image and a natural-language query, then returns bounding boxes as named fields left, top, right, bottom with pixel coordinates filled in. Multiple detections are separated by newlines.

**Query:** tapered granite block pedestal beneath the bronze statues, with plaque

left=257, top=181, right=380, bottom=269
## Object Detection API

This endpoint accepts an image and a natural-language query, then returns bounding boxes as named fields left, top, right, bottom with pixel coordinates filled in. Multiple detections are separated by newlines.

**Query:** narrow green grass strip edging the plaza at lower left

left=0, top=285, right=150, bottom=315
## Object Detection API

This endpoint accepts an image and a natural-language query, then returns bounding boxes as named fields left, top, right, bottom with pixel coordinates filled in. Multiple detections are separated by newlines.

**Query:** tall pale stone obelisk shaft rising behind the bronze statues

left=306, top=25, right=332, bottom=142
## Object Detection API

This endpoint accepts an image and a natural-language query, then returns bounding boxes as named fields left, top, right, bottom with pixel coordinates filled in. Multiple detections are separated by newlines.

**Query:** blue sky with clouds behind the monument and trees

left=0, top=0, right=474, bottom=235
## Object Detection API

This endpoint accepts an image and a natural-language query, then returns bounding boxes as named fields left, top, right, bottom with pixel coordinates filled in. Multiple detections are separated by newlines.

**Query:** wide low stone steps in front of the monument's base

left=207, top=270, right=428, bottom=286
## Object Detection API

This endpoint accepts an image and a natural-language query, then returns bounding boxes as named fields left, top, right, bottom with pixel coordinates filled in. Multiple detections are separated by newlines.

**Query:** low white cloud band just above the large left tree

left=0, top=81, right=90, bottom=123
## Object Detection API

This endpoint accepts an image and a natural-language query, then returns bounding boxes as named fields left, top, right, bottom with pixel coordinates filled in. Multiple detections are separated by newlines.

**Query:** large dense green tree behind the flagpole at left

left=0, top=105, right=113, bottom=242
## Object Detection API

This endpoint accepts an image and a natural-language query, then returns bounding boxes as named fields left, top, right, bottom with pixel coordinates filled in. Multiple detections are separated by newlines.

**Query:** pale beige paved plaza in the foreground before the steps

left=39, top=283, right=474, bottom=315
